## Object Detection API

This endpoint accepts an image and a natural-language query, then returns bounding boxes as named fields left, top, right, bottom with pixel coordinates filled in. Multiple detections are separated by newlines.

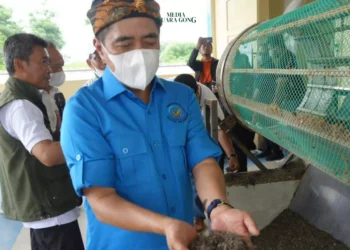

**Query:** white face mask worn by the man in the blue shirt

left=104, top=45, right=159, bottom=90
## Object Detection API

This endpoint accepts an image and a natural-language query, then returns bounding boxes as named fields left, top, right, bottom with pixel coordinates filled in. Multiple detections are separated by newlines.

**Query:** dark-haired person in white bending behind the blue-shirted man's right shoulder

left=174, top=74, right=239, bottom=232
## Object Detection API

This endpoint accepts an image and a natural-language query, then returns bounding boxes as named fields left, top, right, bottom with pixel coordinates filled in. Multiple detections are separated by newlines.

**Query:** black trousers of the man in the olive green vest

left=30, top=221, right=84, bottom=250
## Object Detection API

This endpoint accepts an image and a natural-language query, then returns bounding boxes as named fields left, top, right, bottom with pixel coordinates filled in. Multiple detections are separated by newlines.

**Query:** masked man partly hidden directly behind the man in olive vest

left=41, top=42, right=66, bottom=134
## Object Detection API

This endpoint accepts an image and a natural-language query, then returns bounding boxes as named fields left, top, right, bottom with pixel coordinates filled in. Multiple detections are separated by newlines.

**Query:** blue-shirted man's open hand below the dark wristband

left=210, top=205, right=260, bottom=239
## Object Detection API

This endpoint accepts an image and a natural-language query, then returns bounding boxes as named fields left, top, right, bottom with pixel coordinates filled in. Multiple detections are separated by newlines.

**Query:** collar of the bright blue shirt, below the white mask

left=102, top=67, right=166, bottom=100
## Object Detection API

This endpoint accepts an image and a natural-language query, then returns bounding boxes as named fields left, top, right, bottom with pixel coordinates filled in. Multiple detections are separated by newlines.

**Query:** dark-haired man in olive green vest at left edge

left=0, top=34, right=84, bottom=250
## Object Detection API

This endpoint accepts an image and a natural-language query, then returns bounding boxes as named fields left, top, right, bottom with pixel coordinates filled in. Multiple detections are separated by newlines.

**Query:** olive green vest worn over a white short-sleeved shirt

left=0, top=77, right=79, bottom=222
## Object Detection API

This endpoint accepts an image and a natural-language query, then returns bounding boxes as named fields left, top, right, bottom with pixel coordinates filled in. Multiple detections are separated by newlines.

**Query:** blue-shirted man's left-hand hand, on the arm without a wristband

left=165, top=219, right=197, bottom=250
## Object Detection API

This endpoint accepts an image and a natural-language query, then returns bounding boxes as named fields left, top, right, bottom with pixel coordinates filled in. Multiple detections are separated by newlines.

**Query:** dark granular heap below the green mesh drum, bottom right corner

left=253, top=210, right=350, bottom=250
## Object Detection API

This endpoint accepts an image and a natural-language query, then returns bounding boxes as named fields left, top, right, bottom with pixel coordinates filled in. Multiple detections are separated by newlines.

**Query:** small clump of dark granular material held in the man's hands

left=190, top=232, right=251, bottom=250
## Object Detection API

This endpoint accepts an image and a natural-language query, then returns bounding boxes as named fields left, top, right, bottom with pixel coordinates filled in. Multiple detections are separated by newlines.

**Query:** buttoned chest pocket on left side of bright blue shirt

left=111, top=133, right=152, bottom=186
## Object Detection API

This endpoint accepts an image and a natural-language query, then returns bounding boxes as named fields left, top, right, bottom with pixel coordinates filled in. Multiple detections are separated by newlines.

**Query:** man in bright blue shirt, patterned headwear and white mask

left=62, top=0, right=259, bottom=250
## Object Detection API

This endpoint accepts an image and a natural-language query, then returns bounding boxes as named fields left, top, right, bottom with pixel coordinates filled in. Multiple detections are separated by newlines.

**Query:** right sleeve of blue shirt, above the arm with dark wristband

left=186, top=93, right=222, bottom=169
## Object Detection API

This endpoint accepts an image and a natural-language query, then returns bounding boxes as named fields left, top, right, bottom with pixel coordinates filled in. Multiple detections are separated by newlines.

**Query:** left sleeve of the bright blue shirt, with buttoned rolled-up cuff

left=61, top=93, right=116, bottom=196
